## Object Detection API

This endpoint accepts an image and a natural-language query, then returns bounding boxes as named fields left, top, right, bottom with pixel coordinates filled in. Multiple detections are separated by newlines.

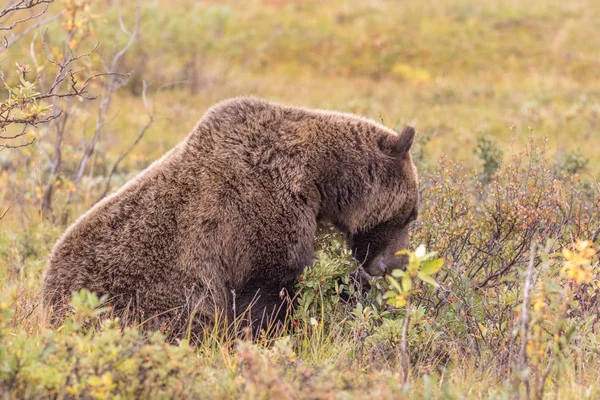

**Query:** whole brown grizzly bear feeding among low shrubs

left=42, top=97, right=419, bottom=336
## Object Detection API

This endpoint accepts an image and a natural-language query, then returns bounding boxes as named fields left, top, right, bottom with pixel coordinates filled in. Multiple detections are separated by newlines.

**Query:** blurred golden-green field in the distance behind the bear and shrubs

left=0, top=0, right=600, bottom=222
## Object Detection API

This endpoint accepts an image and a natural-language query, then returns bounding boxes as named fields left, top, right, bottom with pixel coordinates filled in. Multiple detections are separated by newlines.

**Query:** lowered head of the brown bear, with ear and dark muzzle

left=348, top=127, right=419, bottom=276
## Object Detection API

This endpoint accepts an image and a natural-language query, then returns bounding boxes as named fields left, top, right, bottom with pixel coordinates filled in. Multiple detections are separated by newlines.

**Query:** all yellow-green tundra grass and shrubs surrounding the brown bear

left=0, top=0, right=600, bottom=399
